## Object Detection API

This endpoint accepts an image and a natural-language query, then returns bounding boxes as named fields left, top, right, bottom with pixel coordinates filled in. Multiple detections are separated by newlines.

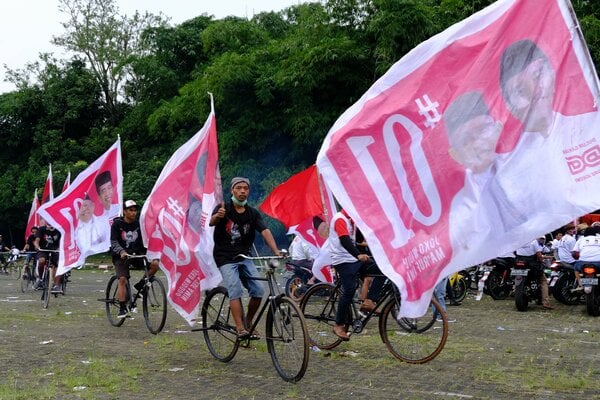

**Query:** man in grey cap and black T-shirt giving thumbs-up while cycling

left=210, top=177, right=280, bottom=337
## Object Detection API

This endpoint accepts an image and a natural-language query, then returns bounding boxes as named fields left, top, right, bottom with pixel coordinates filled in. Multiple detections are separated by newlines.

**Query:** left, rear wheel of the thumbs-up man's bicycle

left=202, top=286, right=240, bottom=362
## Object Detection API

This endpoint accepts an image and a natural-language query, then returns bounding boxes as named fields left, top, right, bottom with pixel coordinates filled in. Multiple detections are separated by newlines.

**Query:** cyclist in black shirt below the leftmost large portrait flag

left=33, top=224, right=62, bottom=294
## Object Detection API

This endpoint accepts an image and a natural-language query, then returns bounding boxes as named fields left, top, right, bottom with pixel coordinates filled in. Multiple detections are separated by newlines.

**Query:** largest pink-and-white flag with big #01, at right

left=317, top=0, right=600, bottom=316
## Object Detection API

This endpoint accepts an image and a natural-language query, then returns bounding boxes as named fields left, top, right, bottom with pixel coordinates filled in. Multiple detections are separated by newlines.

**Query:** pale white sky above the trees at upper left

left=0, top=0, right=306, bottom=93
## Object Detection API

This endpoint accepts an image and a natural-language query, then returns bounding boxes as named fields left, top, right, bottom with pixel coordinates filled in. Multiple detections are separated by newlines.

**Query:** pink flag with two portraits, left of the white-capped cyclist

left=38, top=140, right=123, bottom=274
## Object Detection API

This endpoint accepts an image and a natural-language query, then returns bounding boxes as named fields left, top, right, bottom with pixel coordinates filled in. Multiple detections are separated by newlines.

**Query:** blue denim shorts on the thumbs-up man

left=219, top=260, right=264, bottom=300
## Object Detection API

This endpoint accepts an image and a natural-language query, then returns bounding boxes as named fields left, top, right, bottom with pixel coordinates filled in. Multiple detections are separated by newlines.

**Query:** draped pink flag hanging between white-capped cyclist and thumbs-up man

left=140, top=98, right=222, bottom=325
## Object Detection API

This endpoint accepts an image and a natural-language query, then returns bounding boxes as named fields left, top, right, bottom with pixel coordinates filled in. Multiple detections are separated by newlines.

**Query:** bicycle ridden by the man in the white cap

left=98, top=255, right=167, bottom=335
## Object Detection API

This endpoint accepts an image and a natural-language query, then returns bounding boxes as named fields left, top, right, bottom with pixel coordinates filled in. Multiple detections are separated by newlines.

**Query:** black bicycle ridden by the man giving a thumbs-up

left=192, top=255, right=310, bottom=382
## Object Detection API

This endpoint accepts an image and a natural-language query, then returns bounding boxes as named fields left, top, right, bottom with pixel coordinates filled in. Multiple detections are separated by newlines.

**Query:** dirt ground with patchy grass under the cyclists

left=0, top=269, right=600, bottom=399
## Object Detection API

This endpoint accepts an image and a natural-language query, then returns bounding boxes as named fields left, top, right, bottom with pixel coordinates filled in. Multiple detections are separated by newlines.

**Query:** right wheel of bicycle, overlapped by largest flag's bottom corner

left=379, top=298, right=448, bottom=364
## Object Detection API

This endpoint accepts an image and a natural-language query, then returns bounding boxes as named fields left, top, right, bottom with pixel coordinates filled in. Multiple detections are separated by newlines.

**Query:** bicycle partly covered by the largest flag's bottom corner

left=300, top=275, right=448, bottom=364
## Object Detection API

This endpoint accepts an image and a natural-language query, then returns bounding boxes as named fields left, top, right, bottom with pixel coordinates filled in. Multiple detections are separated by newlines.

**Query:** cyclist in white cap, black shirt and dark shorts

left=110, top=200, right=159, bottom=318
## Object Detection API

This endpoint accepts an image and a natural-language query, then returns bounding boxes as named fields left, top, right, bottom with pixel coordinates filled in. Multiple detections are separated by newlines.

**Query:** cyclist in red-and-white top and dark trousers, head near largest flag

left=328, top=210, right=385, bottom=340
